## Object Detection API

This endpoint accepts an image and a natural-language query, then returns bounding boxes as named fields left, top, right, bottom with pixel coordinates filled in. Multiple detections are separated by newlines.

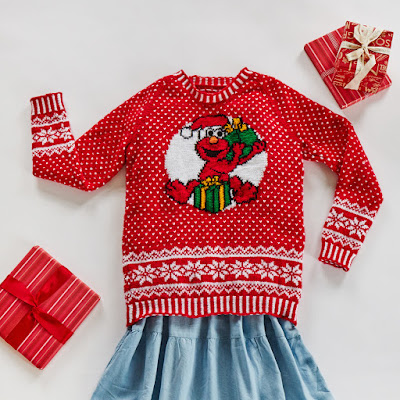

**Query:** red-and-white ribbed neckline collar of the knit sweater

left=173, top=67, right=254, bottom=103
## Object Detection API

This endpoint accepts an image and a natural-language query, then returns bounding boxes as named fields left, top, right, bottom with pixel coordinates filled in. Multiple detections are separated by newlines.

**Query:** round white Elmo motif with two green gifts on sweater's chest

left=165, top=115, right=267, bottom=212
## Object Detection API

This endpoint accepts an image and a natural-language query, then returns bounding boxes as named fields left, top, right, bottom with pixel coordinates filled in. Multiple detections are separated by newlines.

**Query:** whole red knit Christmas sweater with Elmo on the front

left=31, top=68, right=382, bottom=325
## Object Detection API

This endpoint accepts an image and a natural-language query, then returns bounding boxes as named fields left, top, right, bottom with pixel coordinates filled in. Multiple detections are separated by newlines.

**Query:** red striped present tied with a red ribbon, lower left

left=0, top=246, right=100, bottom=369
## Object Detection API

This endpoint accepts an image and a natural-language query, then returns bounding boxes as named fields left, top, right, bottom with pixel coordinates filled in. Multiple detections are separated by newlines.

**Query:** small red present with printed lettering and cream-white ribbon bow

left=333, top=21, right=393, bottom=93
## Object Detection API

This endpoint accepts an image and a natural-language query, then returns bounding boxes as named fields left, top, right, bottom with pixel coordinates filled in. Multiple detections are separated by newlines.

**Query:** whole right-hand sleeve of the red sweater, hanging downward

left=267, top=76, right=383, bottom=271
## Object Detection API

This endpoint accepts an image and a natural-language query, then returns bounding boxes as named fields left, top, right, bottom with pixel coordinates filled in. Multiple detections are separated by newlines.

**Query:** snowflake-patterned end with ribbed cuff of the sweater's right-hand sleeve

left=318, top=198, right=376, bottom=271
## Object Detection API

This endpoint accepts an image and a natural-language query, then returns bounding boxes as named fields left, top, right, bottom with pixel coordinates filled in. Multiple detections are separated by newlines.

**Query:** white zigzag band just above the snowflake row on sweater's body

left=122, top=246, right=303, bottom=266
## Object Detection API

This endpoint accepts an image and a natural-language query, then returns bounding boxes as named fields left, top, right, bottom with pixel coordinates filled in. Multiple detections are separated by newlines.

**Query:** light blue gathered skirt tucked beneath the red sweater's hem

left=92, top=314, right=333, bottom=400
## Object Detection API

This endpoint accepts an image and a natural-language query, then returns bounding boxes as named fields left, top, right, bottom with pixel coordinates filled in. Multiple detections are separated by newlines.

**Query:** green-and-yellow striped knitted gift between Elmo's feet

left=194, top=175, right=231, bottom=213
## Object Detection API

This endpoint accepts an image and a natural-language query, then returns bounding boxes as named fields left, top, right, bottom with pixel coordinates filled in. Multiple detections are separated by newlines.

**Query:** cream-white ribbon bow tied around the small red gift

left=340, top=24, right=390, bottom=90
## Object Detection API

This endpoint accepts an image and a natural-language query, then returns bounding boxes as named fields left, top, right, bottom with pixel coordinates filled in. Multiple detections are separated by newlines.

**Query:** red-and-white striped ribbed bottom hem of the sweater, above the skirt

left=126, top=295, right=298, bottom=326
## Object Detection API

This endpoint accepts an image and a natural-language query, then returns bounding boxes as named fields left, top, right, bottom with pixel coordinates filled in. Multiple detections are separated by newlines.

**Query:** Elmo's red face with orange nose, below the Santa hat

left=196, top=126, right=229, bottom=161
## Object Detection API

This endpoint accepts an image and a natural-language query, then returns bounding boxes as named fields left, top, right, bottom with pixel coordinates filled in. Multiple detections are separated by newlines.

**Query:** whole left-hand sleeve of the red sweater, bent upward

left=31, top=90, right=152, bottom=191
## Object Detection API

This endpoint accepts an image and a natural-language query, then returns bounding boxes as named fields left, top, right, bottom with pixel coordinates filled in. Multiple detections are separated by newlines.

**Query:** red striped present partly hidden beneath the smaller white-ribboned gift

left=304, top=26, right=392, bottom=109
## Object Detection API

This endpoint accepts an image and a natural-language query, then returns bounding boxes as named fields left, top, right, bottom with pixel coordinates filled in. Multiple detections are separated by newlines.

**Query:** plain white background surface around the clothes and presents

left=0, top=0, right=400, bottom=400
